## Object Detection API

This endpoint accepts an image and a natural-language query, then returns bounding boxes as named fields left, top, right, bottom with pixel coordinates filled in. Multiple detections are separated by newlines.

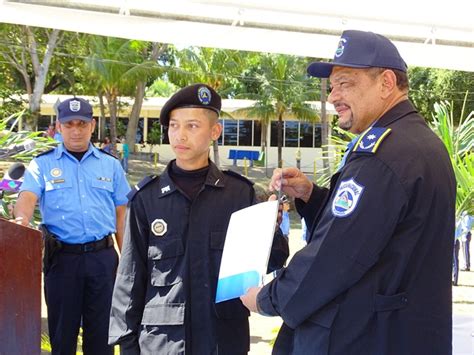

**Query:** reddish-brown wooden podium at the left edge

left=0, top=218, right=42, bottom=355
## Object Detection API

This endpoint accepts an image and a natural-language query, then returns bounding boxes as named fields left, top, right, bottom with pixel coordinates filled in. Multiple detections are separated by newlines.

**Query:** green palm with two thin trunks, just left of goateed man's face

left=241, top=54, right=318, bottom=167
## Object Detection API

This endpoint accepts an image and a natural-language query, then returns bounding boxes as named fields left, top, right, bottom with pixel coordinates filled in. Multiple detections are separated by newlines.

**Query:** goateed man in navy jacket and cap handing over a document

left=242, top=31, right=456, bottom=355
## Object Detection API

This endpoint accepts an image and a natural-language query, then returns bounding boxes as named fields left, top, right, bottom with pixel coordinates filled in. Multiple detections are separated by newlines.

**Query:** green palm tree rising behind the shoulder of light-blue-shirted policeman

left=87, top=36, right=158, bottom=153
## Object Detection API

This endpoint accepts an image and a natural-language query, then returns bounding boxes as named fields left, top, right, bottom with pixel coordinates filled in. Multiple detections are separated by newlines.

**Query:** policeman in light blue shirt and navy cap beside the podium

left=14, top=98, right=130, bottom=355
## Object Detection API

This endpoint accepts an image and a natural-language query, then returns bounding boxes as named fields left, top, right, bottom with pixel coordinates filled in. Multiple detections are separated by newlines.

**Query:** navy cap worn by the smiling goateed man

left=308, top=30, right=407, bottom=78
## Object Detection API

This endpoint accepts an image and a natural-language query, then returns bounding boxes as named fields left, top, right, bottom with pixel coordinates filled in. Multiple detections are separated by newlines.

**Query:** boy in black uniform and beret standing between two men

left=109, top=84, right=288, bottom=355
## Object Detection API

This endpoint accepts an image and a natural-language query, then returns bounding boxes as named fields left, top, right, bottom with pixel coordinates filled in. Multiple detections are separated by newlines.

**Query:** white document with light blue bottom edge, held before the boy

left=216, top=201, right=278, bottom=303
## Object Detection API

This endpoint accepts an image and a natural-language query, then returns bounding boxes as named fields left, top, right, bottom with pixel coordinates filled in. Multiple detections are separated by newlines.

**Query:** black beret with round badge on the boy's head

left=160, top=84, right=222, bottom=126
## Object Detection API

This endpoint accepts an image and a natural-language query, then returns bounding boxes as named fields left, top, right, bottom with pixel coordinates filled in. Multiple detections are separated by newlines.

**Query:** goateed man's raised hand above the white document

left=269, top=168, right=313, bottom=202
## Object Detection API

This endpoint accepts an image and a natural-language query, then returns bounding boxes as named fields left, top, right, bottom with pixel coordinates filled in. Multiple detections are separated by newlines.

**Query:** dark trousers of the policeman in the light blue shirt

left=44, top=247, right=118, bottom=355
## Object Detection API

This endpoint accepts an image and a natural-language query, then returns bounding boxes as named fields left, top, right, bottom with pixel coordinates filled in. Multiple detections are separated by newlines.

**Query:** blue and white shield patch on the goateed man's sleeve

left=332, top=178, right=364, bottom=217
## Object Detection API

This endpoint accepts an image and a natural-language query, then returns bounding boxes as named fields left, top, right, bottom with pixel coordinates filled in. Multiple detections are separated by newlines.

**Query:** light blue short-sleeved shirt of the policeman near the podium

left=21, top=143, right=130, bottom=244
